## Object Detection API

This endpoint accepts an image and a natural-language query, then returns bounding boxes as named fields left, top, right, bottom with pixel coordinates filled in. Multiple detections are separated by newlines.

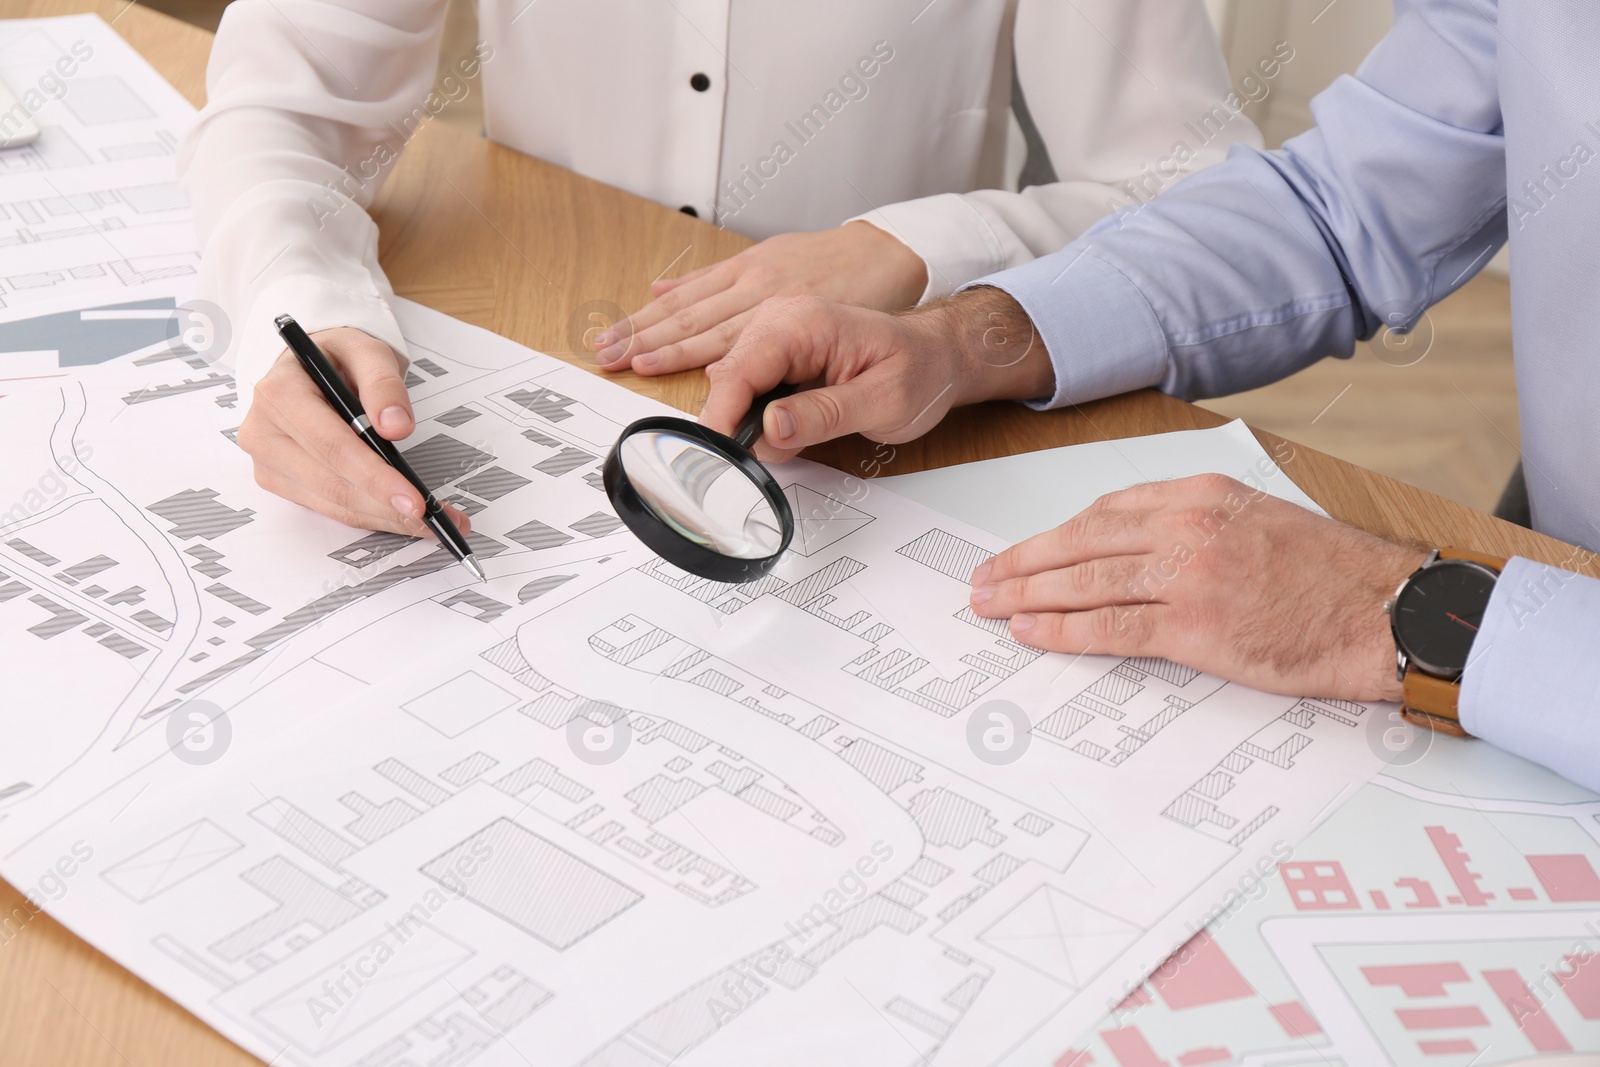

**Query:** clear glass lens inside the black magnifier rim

left=618, top=430, right=784, bottom=560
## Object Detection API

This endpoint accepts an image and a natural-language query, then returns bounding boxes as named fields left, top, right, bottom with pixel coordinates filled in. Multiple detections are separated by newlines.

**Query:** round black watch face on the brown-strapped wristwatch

left=1394, top=560, right=1496, bottom=678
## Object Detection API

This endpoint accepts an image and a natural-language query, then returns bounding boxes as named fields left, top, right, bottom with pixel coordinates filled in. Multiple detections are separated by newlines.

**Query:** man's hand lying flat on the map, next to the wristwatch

left=971, top=475, right=1424, bottom=701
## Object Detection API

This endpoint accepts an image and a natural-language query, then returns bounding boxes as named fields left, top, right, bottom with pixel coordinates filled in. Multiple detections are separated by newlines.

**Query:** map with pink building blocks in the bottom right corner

left=1056, top=737, right=1600, bottom=1067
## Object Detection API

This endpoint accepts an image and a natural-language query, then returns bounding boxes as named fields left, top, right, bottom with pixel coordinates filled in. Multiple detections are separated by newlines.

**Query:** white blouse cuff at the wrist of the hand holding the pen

left=234, top=274, right=410, bottom=406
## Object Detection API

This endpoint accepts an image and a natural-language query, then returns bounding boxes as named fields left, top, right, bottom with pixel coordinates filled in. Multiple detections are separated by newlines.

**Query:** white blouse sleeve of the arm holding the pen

left=178, top=0, right=464, bottom=403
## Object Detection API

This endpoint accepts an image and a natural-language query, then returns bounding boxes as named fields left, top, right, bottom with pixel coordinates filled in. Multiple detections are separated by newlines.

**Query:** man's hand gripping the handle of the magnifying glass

left=701, top=288, right=1054, bottom=462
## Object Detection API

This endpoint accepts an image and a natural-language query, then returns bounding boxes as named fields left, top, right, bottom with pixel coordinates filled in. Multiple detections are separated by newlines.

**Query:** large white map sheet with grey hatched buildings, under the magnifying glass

left=0, top=295, right=1381, bottom=1067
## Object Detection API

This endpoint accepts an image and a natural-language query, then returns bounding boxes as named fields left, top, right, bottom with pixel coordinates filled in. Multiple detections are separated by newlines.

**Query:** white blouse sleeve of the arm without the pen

left=858, top=0, right=1260, bottom=301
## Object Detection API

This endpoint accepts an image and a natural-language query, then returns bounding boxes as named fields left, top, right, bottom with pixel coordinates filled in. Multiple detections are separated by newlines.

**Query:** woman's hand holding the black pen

left=238, top=326, right=469, bottom=537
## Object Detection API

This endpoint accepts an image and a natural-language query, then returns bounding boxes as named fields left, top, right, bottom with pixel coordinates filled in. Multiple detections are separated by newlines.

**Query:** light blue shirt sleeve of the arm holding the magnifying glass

left=978, top=0, right=1506, bottom=403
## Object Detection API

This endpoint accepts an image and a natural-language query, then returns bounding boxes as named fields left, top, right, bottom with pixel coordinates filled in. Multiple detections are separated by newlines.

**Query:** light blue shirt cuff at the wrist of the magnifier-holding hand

left=962, top=245, right=1166, bottom=408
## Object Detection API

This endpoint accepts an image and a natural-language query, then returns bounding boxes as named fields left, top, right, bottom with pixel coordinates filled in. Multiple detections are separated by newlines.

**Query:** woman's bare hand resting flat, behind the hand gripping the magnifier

left=594, top=222, right=928, bottom=374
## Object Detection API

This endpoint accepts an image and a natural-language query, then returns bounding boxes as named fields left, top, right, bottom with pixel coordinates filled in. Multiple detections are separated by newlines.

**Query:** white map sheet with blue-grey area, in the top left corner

left=0, top=14, right=200, bottom=383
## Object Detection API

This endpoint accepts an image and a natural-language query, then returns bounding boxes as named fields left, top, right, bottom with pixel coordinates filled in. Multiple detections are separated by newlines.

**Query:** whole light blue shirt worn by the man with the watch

left=979, top=0, right=1600, bottom=789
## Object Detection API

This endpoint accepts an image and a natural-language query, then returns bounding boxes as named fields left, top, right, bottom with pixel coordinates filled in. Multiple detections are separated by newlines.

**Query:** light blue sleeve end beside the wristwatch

left=1459, top=558, right=1600, bottom=790
